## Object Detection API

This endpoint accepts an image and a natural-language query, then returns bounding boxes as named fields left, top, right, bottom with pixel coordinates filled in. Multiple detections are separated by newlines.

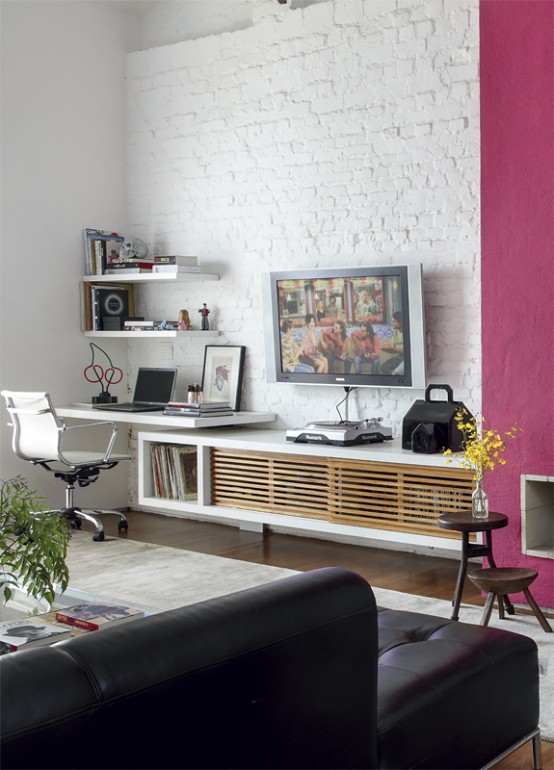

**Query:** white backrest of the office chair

left=1, top=390, right=63, bottom=461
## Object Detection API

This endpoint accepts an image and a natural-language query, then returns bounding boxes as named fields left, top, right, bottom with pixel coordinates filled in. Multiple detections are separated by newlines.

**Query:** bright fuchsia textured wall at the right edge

left=480, top=0, right=554, bottom=607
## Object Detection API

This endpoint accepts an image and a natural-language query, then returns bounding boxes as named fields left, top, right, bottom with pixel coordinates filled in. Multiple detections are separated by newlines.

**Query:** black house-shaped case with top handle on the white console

left=402, top=385, right=472, bottom=454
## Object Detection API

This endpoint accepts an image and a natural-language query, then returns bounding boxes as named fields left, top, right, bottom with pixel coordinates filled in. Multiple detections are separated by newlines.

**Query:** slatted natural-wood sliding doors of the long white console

left=211, top=447, right=472, bottom=536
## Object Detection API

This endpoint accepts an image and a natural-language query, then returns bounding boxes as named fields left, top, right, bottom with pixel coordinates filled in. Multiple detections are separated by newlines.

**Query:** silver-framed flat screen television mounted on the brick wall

left=262, top=264, right=426, bottom=388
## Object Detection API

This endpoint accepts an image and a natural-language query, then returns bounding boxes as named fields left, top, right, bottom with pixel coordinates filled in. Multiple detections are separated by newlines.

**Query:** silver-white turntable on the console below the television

left=286, top=417, right=392, bottom=446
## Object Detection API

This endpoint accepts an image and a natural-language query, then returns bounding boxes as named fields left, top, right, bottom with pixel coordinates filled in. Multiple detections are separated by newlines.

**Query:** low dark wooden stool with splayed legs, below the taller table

left=468, top=567, right=552, bottom=632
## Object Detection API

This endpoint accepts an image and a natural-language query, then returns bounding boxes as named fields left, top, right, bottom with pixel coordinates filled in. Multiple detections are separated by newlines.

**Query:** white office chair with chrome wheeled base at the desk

left=1, top=390, right=131, bottom=541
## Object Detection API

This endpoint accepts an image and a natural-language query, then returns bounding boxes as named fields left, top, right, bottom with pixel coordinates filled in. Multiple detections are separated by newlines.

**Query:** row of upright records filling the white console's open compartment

left=150, top=444, right=198, bottom=500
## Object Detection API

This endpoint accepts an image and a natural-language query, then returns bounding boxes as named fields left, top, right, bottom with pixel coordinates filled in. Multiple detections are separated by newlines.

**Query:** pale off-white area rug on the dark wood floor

left=68, top=532, right=554, bottom=741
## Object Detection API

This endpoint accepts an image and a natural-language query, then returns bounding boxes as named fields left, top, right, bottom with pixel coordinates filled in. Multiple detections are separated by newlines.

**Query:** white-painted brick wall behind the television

left=127, top=0, right=481, bottom=435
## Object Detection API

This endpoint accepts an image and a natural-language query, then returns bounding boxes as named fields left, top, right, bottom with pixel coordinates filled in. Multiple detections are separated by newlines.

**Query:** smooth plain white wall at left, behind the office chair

left=0, top=0, right=138, bottom=505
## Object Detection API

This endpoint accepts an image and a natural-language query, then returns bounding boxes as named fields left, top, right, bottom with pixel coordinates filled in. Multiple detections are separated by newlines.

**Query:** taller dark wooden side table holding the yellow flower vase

left=437, top=510, right=514, bottom=620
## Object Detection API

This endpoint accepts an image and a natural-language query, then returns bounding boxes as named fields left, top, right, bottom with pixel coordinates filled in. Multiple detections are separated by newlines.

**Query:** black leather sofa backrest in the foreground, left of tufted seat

left=0, top=569, right=377, bottom=768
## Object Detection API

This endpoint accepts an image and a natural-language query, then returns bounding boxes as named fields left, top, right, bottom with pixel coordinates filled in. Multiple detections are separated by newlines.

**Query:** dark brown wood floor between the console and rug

left=106, top=511, right=554, bottom=770
